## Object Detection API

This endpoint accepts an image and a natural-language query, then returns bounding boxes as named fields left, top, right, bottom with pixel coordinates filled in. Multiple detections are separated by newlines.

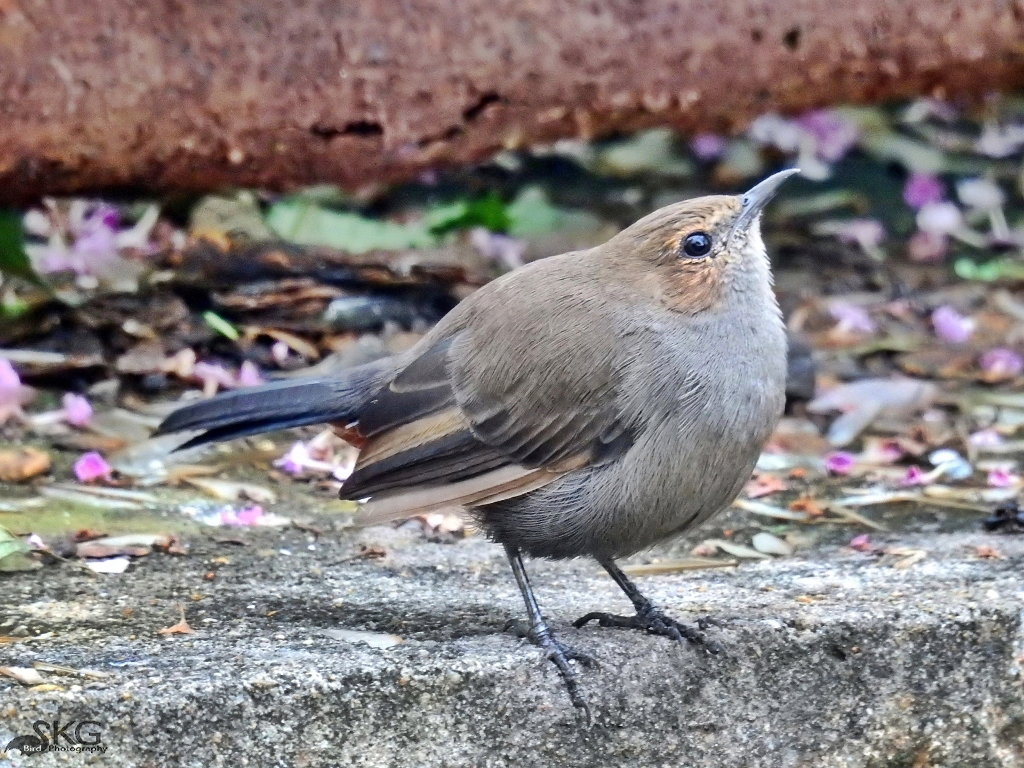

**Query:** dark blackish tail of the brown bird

left=157, top=358, right=394, bottom=451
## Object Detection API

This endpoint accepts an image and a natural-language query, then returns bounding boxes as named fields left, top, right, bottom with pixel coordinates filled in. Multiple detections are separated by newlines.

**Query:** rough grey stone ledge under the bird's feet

left=0, top=527, right=1024, bottom=768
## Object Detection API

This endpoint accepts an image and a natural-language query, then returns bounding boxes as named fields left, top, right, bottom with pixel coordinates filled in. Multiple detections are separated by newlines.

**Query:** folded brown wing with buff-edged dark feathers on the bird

left=342, top=286, right=634, bottom=520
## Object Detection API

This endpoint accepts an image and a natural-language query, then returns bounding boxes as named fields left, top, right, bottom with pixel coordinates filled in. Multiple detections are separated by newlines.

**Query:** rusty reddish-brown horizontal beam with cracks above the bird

left=0, top=0, right=1024, bottom=203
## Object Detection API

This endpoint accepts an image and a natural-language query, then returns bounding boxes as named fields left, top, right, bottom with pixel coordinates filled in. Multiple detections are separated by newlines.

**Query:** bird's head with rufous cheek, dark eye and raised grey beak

left=612, top=169, right=798, bottom=314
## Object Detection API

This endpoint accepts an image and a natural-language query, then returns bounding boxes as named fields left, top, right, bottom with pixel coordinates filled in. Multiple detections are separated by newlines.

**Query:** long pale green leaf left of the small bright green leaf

left=266, top=199, right=437, bottom=253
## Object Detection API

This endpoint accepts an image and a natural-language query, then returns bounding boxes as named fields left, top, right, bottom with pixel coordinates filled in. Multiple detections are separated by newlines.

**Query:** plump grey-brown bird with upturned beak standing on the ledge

left=160, top=170, right=796, bottom=720
